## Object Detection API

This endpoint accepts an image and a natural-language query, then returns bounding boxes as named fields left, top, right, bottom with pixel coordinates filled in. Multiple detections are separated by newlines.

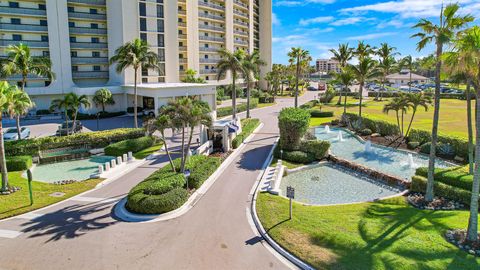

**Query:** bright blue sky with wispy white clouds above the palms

left=273, top=0, right=480, bottom=64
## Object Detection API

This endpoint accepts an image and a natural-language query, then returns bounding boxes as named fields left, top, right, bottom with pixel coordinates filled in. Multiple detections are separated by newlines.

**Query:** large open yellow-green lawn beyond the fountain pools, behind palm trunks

left=322, top=97, right=474, bottom=138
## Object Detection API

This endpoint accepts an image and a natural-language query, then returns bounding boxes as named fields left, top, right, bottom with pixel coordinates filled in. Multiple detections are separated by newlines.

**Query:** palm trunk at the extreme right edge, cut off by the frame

left=467, top=83, right=480, bottom=241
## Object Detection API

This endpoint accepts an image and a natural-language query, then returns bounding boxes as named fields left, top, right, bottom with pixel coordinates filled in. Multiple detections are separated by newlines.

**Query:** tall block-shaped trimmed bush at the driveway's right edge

left=278, top=108, right=310, bottom=150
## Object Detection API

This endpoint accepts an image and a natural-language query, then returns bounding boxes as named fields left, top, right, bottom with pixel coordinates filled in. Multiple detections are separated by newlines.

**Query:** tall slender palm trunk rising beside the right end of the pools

left=425, top=42, right=443, bottom=202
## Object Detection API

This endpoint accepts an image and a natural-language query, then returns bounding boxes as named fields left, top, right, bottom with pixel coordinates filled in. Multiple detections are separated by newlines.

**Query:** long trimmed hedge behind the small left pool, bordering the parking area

left=5, top=128, right=145, bottom=156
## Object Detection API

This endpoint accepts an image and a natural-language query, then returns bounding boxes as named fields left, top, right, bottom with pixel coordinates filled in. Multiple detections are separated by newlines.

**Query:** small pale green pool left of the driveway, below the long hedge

left=32, top=156, right=114, bottom=183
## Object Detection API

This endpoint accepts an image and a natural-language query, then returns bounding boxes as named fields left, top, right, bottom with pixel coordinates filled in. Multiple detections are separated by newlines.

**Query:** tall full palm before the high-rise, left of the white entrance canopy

left=110, top=38, right=160, bottom=128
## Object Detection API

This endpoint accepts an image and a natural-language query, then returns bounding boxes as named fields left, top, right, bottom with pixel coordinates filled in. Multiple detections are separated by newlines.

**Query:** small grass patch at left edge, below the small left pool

left=0, top=172, right=102, bottom=219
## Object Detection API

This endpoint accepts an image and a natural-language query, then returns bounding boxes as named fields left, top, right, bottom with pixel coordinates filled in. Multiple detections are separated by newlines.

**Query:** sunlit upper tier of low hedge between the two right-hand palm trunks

left=415, top=167, right=473, bottom=191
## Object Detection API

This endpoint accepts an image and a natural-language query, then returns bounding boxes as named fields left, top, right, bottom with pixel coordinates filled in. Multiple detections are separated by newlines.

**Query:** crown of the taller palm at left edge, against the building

left=1, top=43, right=55, bottom=91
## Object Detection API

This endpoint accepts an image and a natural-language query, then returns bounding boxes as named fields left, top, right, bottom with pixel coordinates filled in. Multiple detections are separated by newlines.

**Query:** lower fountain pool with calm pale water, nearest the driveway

left=280, top=163, right=401, bottom=205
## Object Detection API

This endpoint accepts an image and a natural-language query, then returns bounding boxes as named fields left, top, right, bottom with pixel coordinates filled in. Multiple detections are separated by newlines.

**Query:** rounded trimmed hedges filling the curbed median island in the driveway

left=126, top=156, right=221, bottom=214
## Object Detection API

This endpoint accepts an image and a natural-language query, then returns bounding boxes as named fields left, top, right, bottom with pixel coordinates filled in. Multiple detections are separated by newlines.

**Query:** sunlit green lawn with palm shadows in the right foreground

left=257, top=193, right=480, bottom=270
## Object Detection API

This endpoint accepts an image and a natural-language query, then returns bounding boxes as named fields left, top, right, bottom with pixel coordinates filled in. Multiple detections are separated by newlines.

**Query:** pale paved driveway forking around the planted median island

left=0, top=93, right=313, bottom=270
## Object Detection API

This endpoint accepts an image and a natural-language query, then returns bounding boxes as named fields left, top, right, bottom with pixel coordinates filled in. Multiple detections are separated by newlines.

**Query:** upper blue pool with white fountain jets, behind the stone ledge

left=315, top=127, right=452, bottom=181
